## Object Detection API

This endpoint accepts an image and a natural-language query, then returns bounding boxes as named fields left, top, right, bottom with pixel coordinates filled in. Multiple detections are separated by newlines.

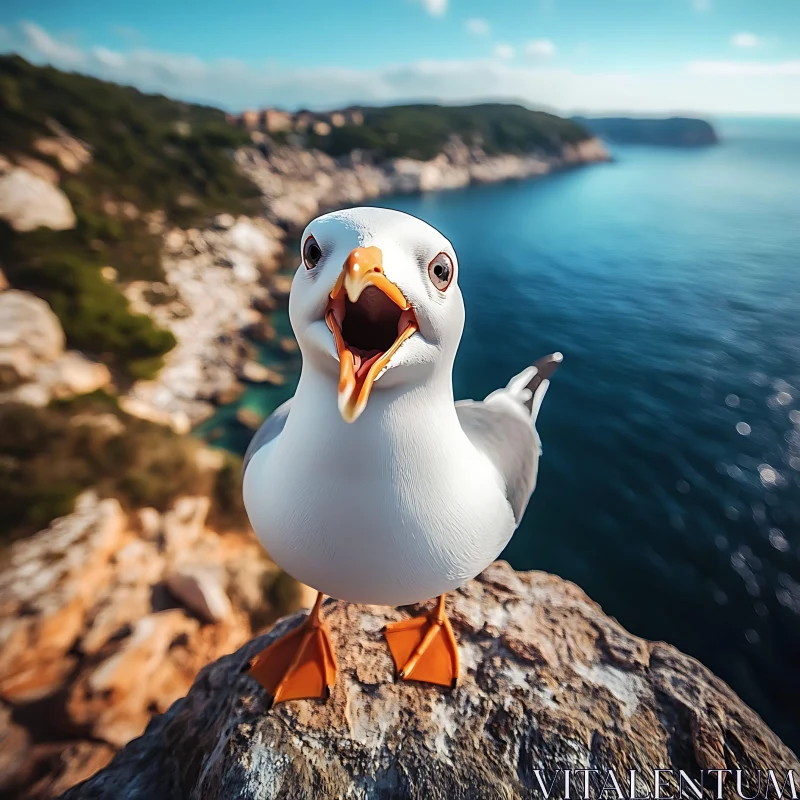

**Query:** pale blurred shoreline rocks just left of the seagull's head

left=122, top=214, right=283, bottom=432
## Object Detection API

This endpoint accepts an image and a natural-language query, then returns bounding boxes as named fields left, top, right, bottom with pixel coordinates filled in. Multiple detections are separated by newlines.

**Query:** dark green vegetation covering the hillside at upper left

left=0, top=56, right=258, bottom=378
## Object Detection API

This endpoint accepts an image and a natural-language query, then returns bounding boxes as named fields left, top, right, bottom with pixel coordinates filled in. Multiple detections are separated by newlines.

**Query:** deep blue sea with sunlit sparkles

left=206, top=120, right=800, bottom=751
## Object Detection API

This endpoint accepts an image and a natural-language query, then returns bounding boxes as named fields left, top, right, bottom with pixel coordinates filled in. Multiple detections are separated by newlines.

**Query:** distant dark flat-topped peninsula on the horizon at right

left=572, top=117, right=719, bottom=147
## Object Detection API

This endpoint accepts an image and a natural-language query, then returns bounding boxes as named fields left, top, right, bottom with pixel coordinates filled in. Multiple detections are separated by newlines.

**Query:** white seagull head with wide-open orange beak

left=289, top=208, right=464, bottom=422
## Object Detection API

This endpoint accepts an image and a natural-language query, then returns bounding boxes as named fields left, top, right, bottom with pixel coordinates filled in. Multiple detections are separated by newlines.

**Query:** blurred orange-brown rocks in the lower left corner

left=0, top=493, right=307, bottom=798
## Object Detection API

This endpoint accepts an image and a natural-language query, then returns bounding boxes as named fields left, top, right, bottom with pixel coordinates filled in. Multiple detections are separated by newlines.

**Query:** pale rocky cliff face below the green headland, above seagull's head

left=236, top=137, right=609, bottom=233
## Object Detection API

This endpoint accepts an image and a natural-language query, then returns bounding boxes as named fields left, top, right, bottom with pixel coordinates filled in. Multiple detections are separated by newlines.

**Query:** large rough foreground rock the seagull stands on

left=61, top=563, right=800, bottom=800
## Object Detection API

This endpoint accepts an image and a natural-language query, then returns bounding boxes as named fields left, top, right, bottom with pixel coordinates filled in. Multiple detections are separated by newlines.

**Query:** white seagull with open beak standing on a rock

left=243, top=208, right=562, bottom=703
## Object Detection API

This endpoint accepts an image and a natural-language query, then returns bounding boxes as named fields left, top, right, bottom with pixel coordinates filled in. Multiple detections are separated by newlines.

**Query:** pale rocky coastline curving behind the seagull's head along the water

left=121, top=137, right=611, bottom=433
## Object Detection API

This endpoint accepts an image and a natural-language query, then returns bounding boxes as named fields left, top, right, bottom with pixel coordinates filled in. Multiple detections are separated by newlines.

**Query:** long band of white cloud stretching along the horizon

left=7, top=26, right=800, bottom=115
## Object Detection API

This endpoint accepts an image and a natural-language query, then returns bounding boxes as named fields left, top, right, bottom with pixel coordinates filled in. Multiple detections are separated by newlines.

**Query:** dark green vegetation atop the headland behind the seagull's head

left=310, top=103, right=589, bottom=160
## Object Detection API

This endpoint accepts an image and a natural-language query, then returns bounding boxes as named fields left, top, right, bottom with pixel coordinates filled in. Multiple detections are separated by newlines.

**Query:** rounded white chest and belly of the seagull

left=244, top=382, right=515, bottom=605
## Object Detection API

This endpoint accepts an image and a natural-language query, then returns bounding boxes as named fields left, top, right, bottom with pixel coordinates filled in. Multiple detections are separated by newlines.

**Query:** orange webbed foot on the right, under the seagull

left=384, top=595, right=459, bottom=688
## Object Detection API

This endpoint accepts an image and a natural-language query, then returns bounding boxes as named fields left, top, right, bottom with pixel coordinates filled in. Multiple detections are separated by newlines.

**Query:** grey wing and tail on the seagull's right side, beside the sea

left=456, top=353, right=562, bottom=525
